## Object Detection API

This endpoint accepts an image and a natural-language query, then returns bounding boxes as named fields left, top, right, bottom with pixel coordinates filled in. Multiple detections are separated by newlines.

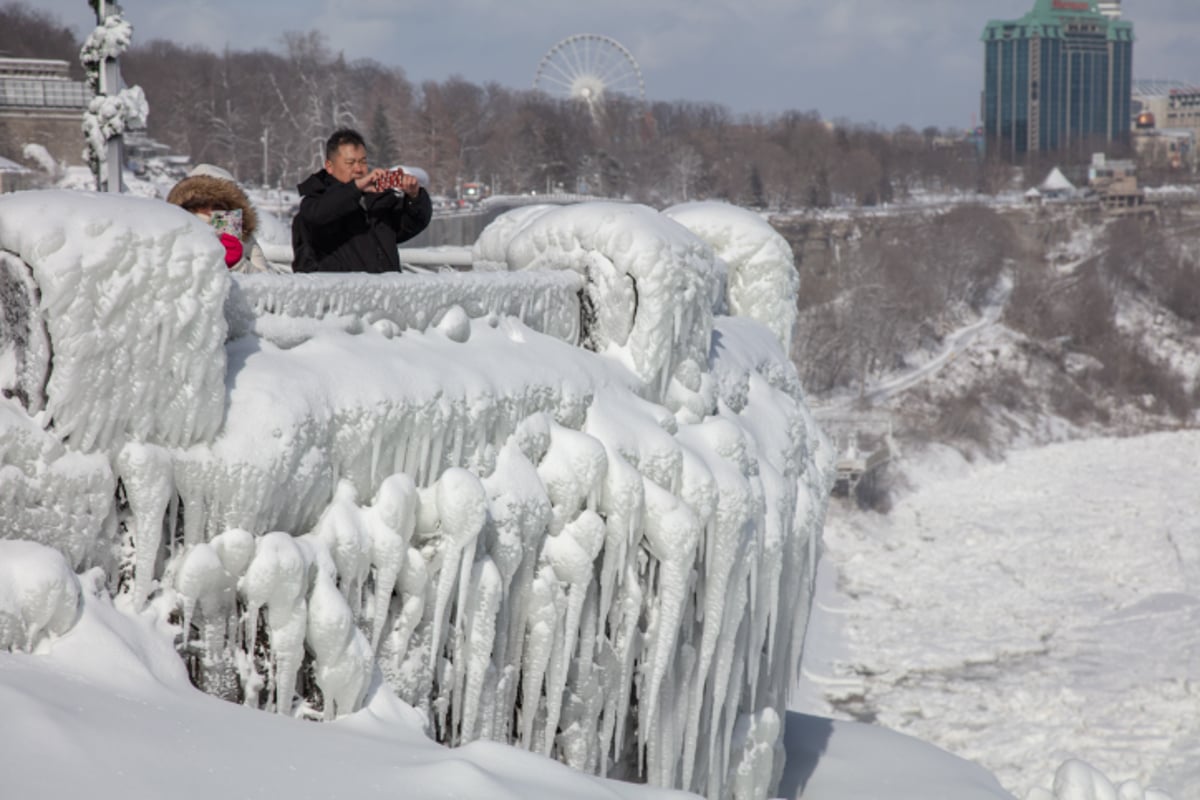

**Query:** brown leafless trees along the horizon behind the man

left=0, top=4, right=986, bottom=207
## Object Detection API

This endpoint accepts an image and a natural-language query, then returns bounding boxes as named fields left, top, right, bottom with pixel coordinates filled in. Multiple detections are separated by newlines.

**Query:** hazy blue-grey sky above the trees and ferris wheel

left=28, top=0, right=1200, bottom=128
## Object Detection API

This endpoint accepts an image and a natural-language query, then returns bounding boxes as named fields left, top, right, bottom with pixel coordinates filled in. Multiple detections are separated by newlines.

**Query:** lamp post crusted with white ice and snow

left=79, top=0, right=149, bottom=192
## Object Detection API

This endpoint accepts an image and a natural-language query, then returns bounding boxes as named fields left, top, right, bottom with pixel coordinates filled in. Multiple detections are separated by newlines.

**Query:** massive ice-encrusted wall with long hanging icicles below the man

left=0, top=193, right=832, bottom=798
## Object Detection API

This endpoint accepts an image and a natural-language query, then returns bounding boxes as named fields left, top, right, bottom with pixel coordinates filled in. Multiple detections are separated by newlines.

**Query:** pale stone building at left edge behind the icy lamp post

left=0, top=58, right=91, bottom=164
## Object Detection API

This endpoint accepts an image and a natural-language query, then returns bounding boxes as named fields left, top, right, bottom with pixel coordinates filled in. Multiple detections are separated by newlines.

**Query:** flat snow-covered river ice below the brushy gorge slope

left=793, top=432, right=1200, bottom=800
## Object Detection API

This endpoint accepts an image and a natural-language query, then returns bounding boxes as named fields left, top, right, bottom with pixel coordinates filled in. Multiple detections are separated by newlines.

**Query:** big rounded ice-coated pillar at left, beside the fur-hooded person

left=0, top=191, right=229, bottom=451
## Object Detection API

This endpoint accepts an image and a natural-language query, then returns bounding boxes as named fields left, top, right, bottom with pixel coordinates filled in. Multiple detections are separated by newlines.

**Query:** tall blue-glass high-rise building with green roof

left=982, top=0, right=1133, bottom=160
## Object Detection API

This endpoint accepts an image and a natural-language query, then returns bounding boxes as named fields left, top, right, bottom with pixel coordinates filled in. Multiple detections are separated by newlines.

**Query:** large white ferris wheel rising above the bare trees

left=533, top=34, right=646, bottom=113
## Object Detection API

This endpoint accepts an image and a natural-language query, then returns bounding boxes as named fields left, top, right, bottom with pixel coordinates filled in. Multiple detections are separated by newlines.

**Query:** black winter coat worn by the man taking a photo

left=292, top=169, right=433, bottom=272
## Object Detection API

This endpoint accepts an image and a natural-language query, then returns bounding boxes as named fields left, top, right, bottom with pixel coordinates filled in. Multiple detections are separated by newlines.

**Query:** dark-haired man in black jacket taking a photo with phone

left=292, top=128, right=433, bottom=272
